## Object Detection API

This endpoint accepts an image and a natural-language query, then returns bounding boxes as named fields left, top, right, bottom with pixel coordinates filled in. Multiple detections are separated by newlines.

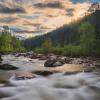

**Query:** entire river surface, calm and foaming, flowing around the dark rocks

left=0, top=55, right=100, bottom=100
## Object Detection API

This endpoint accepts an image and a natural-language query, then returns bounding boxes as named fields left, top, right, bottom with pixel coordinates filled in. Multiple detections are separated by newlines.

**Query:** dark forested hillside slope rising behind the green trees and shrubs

left=25, top=4, right=100, bottom=48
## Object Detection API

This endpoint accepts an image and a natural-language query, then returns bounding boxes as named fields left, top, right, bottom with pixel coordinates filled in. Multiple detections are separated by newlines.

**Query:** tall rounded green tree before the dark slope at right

left=79, top=22, right=96, bottom=55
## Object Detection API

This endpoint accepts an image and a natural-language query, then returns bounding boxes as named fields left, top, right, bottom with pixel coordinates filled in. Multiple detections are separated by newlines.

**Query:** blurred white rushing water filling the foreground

left=0, top=56, right=100, bottom=100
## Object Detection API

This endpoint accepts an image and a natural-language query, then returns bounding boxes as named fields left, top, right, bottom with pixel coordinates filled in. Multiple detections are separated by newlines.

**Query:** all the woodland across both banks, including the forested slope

left=0, top=10, right=100, bottom=56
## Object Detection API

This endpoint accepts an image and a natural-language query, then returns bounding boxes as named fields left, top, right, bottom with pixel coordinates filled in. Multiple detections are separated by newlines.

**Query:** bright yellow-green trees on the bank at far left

left=0, top=30, right=25, bottom=53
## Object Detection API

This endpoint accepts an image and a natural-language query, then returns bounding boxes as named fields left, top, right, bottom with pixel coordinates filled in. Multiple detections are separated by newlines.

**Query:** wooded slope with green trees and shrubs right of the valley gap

left=24, top=10, right=100, bottom=56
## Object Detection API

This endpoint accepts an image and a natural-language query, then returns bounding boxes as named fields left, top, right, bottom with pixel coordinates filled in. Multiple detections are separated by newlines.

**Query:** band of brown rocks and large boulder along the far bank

left=15, top=53, right=100, bottom=68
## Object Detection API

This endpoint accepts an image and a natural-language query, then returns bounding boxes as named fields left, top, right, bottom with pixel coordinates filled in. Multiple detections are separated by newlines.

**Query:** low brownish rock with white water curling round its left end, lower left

left=15, top=72, right=35, bottom=80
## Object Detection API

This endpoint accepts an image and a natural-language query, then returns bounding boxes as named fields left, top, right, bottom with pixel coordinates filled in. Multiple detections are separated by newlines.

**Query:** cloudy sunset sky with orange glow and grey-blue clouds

left=0, top=0, right=100, bottom=37
